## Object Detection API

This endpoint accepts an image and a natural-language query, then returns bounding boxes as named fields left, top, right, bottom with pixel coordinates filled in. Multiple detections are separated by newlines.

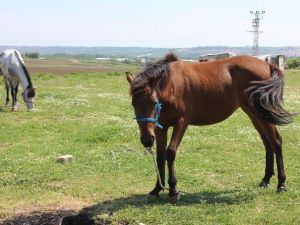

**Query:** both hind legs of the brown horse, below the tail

left=244, top=110, right=286, bottom=192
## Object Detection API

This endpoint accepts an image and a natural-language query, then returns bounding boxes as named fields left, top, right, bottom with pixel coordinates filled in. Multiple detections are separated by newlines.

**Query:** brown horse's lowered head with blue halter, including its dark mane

left=126, top=52, right=178, bottom=147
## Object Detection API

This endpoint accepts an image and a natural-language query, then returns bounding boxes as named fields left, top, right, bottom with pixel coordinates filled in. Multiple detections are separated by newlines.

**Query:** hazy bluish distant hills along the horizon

left=0, top=46, right=300, bottom=59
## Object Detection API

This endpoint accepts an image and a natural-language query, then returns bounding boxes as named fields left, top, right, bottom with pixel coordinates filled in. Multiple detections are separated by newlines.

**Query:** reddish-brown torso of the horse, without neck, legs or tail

left=170, top=56, right=270, bottom=125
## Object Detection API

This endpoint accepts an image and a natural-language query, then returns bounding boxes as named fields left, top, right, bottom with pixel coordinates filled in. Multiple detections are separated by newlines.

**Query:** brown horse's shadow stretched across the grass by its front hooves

left=62, top=190, right=255, bottom=225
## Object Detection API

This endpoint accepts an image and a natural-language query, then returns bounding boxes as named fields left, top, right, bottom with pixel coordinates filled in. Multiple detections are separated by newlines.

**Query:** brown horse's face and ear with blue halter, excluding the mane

left=126, top=72, right=162, bottom=148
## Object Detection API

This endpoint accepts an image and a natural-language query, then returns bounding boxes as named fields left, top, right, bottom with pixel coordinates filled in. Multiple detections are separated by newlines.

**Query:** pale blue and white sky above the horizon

left=0, top=0, right=300, bottom=48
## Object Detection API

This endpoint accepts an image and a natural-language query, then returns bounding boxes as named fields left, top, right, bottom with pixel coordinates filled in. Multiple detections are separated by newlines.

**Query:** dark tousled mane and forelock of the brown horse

left=130, top=52, right=178, bottom=95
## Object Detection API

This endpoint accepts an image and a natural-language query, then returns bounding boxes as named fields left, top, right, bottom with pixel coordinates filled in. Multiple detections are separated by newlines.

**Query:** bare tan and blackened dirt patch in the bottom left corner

left=0, top=200, right=129, bottom=225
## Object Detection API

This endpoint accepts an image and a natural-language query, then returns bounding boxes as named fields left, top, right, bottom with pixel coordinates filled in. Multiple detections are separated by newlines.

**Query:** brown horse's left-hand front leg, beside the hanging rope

left=149, top=128, right=168, bottom=197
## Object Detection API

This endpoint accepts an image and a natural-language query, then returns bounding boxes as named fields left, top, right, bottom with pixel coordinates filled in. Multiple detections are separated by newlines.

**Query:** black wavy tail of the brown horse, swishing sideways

left=246, top=64, right=293, bottom=125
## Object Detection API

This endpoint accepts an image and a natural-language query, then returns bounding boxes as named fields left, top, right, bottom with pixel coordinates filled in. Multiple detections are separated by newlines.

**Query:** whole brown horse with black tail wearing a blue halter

left=126, top=53, right=292, bottom=202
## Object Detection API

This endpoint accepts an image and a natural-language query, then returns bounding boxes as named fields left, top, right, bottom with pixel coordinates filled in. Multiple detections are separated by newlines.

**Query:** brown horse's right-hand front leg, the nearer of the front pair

left=167, top=118, right=188, bottom=202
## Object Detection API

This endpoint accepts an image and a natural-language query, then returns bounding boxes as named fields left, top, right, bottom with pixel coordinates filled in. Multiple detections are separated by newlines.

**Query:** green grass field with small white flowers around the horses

left=0, top=64, right=300, bottom=225
